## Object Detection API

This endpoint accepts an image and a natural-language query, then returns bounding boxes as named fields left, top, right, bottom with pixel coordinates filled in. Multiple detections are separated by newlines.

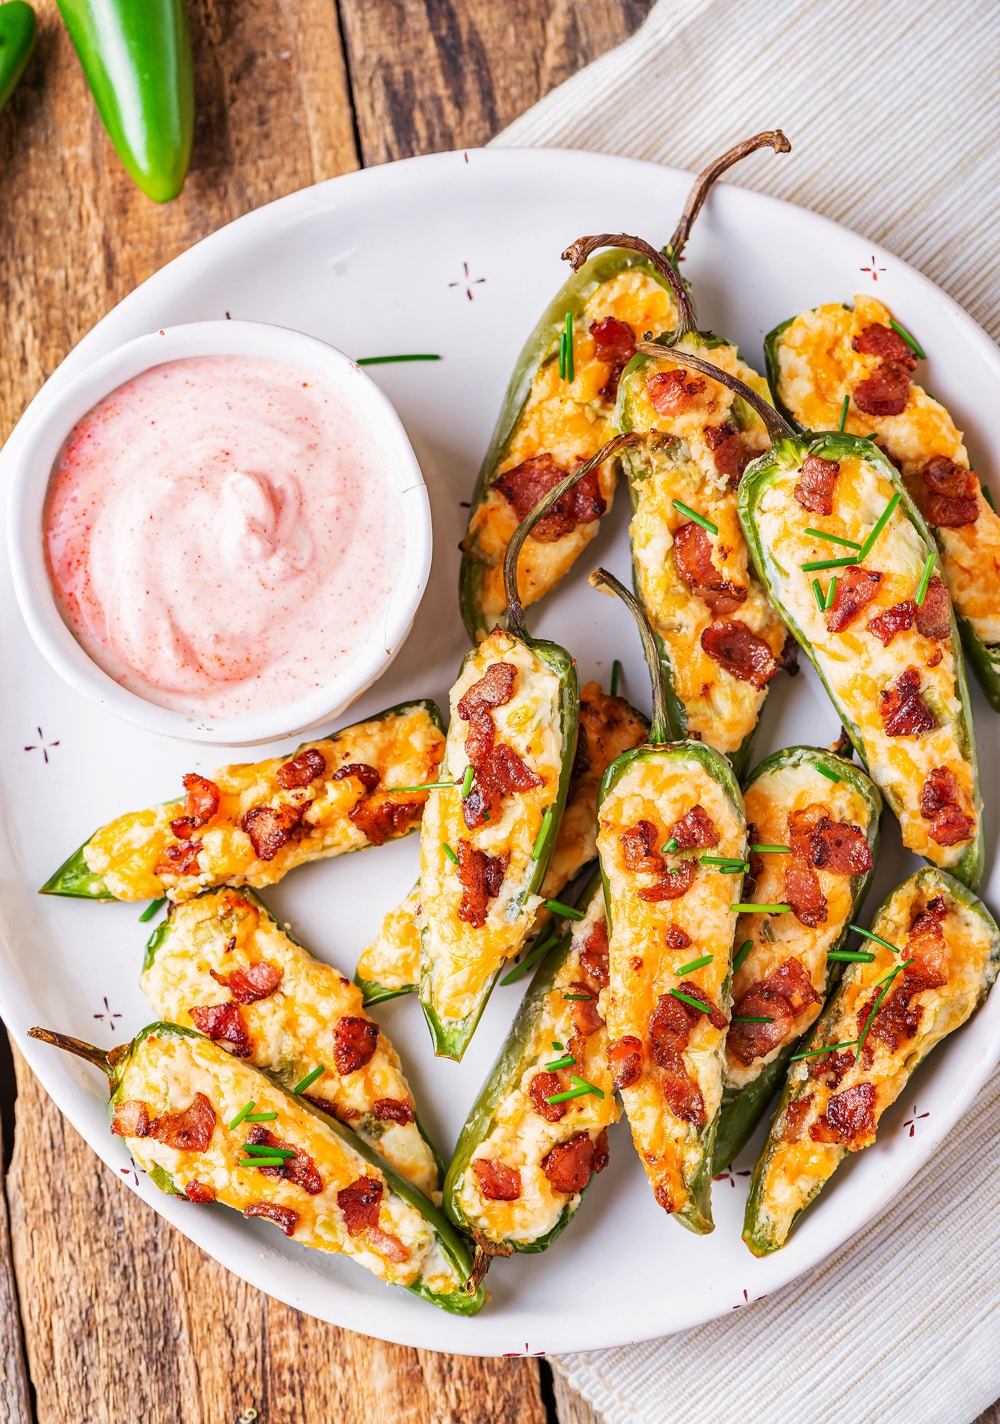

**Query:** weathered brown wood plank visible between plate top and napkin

left=340, top=0, right=652, bottom=164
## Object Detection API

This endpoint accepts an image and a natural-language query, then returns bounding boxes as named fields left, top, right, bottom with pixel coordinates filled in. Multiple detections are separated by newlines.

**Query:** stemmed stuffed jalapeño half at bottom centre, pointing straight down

left=591, top=570, right=746, bottom=1233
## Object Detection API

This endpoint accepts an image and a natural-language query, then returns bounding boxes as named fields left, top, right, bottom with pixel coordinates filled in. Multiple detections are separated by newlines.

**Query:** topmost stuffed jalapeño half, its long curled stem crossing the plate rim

left=460, top=131, right=791, bottom=642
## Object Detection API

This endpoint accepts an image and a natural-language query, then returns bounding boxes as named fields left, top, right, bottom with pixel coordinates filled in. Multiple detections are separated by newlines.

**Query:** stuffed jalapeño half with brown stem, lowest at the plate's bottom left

left=31, top=1024, right=484, bottom=1316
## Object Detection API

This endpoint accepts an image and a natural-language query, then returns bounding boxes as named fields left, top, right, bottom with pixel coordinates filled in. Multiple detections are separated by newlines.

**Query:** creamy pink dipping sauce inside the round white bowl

left=44, top=356, right=405, bottom=718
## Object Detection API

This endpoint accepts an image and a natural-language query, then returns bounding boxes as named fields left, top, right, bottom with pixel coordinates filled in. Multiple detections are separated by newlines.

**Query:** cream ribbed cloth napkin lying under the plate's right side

left=494, top=0, right=1000, bottom=1424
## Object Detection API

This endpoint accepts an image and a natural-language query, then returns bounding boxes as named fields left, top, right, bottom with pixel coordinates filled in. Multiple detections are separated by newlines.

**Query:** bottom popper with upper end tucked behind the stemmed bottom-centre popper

left=444, top=874, right=621, bottom=1256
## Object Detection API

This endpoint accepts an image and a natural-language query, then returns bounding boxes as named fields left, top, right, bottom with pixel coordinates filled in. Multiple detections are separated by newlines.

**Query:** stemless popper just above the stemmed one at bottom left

left=141, top=890, right=440, bottom=1198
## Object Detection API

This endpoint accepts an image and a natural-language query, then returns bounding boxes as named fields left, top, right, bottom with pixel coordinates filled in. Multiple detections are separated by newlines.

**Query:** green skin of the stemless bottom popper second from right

left=712, top=746, right=882, bottom=1173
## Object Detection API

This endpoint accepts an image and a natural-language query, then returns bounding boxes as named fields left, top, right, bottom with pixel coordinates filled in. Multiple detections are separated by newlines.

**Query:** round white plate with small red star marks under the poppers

left=0, top=150, right=1000, bottom=1354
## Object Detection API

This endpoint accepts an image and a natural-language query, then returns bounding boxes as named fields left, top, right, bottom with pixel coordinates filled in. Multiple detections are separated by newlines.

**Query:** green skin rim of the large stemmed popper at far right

left=738, top=433, right=986, bottom=889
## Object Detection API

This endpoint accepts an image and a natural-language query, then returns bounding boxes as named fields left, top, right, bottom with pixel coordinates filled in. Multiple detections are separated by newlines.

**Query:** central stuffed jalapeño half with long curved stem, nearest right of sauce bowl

left=419, top=436, right=630, bottom=1058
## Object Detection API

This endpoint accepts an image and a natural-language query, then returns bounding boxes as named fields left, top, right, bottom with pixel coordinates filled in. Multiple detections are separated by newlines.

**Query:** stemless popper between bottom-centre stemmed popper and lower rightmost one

left=715, top=746, right=882, bottom=1172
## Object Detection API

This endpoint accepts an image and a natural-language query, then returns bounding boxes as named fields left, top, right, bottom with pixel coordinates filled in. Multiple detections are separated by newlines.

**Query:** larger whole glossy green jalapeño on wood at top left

left=57, top=0, right=194, bottom=202
